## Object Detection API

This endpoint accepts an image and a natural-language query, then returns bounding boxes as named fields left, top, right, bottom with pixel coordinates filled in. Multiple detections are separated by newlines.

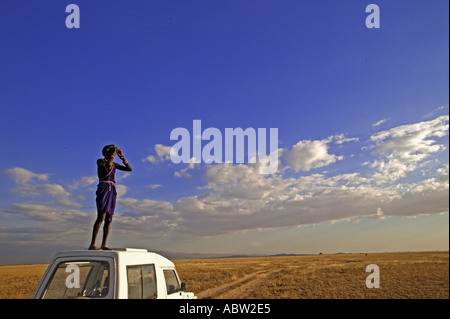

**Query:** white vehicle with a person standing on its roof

left=32, top=248, right=197, bottom=299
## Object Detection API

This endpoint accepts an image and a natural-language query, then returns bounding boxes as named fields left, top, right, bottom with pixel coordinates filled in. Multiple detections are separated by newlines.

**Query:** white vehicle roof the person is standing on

left=51, top=248, right=175, bottom=268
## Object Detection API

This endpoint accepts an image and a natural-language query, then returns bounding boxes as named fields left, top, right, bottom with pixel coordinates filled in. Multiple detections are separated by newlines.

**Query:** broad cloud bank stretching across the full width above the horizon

left=0, top=115, right=449, bottom=250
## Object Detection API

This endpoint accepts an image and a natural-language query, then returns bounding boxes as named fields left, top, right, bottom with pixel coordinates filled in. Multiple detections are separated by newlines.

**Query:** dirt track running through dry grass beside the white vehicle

left=197, top=269, right=280, bottom=299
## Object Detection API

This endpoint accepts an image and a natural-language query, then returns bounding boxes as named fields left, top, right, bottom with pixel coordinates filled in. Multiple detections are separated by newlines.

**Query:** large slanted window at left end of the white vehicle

left=42, top=260, right=110, bottom=299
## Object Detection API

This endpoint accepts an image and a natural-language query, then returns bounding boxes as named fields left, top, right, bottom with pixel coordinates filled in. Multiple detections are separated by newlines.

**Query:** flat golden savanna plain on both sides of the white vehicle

left=0, top=252, right=449, bottom=299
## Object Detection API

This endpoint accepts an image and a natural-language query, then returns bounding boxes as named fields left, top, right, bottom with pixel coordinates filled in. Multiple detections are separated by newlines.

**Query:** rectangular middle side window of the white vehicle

left=127, top=265, right=156, bottom=299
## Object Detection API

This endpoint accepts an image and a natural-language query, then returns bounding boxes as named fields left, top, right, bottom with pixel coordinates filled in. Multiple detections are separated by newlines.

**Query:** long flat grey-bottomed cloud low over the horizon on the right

left=174, top=166, right=448, bottom=236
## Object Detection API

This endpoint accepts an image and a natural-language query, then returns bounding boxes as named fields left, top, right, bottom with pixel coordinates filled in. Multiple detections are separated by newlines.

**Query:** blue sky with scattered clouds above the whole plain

left=0, top=0, right=449, bottom=263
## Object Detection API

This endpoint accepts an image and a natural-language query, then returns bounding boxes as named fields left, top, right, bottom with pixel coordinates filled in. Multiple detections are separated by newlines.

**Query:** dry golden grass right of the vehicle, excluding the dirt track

left=175, top=252, right=449, bottom=299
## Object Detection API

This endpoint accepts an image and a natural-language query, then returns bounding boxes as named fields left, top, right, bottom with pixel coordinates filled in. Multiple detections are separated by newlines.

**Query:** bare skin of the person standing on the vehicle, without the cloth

left=89, top=148, right=132, bottom=250
